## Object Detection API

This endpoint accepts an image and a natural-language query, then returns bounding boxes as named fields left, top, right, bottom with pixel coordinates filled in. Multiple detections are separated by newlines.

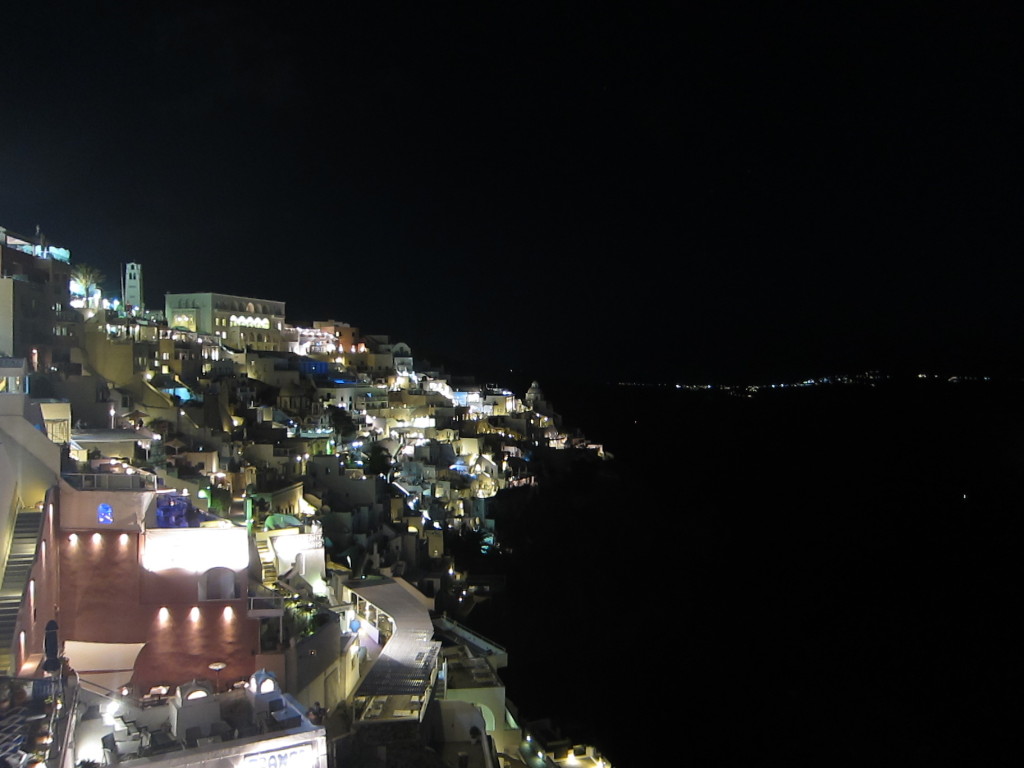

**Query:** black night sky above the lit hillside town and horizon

left=0, top=2, right=1024, bottom=382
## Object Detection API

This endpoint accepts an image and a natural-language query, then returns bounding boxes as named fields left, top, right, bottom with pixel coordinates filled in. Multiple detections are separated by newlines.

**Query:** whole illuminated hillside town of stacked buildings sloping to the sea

left=0, top=227, right=609, bottom=768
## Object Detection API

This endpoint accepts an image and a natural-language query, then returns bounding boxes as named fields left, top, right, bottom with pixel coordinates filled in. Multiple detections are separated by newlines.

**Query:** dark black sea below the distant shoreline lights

left=467, top=376, right=1024, bottom=767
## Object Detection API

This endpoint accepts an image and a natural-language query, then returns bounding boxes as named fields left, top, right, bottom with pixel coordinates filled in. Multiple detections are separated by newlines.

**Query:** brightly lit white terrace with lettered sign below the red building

left=0, top=663, right=328, bottom=768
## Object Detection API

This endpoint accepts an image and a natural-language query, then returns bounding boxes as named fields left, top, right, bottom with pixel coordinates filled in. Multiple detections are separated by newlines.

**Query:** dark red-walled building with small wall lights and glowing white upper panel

left=32, top=468, right=264, bottom=692
